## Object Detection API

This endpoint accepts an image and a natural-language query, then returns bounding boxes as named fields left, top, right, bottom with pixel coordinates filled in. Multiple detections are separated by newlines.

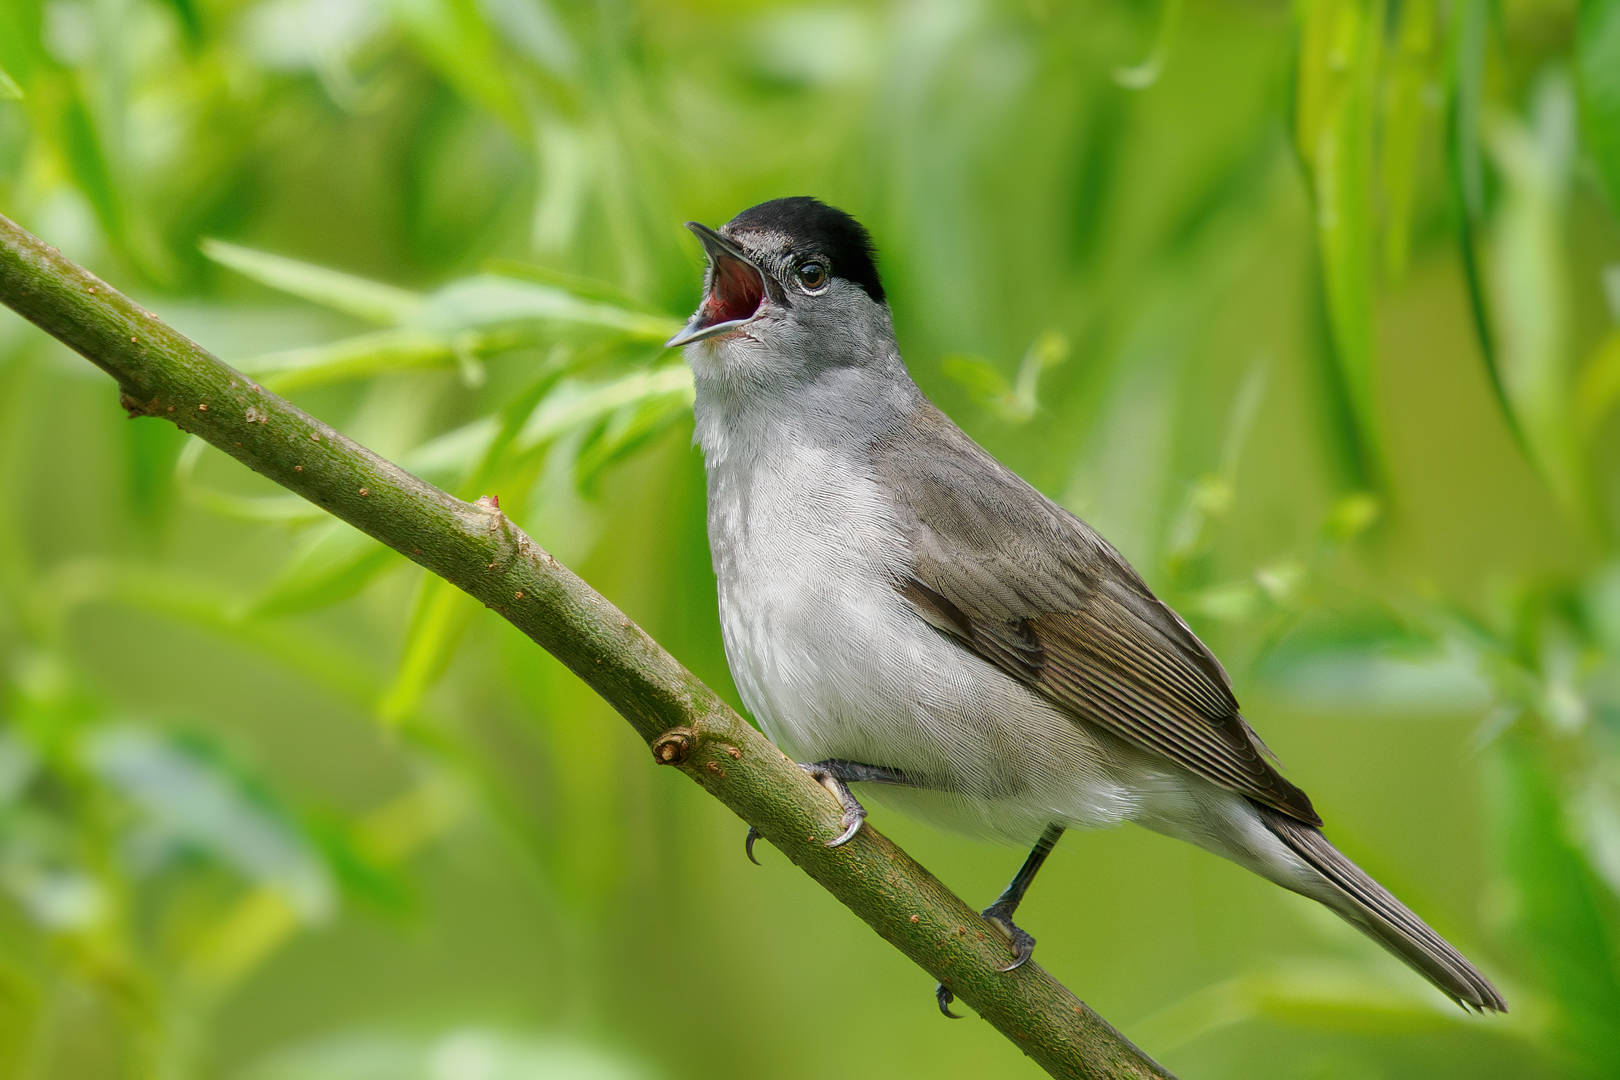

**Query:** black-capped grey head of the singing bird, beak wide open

left=669, top=196, right=894, bottom=381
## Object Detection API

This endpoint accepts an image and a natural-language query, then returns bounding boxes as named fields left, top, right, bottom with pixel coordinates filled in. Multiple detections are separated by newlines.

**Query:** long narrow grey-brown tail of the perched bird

left=1254, top=803, right=1508, bottom=1012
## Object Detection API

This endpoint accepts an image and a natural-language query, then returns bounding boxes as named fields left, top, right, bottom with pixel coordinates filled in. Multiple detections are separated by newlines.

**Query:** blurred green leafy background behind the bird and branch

left=0, top=0, right=1620, bottom=1080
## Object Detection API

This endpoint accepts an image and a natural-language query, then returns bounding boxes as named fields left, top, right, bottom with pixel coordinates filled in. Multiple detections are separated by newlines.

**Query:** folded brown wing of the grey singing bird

left=875, top=410, right=1322, bottom=826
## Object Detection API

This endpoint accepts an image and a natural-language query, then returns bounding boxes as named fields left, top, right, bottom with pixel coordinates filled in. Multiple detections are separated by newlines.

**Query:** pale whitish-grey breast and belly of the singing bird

left=710, top=447, right=1136, bottom=842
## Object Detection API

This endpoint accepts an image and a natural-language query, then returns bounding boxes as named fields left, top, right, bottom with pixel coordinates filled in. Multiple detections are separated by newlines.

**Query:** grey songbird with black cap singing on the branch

left=667, top=196, right=1507, bottom=1017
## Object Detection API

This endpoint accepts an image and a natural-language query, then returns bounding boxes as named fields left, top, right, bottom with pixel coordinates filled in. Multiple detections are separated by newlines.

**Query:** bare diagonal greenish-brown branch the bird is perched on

left=0, top=217, right=1171, bottom=1080
